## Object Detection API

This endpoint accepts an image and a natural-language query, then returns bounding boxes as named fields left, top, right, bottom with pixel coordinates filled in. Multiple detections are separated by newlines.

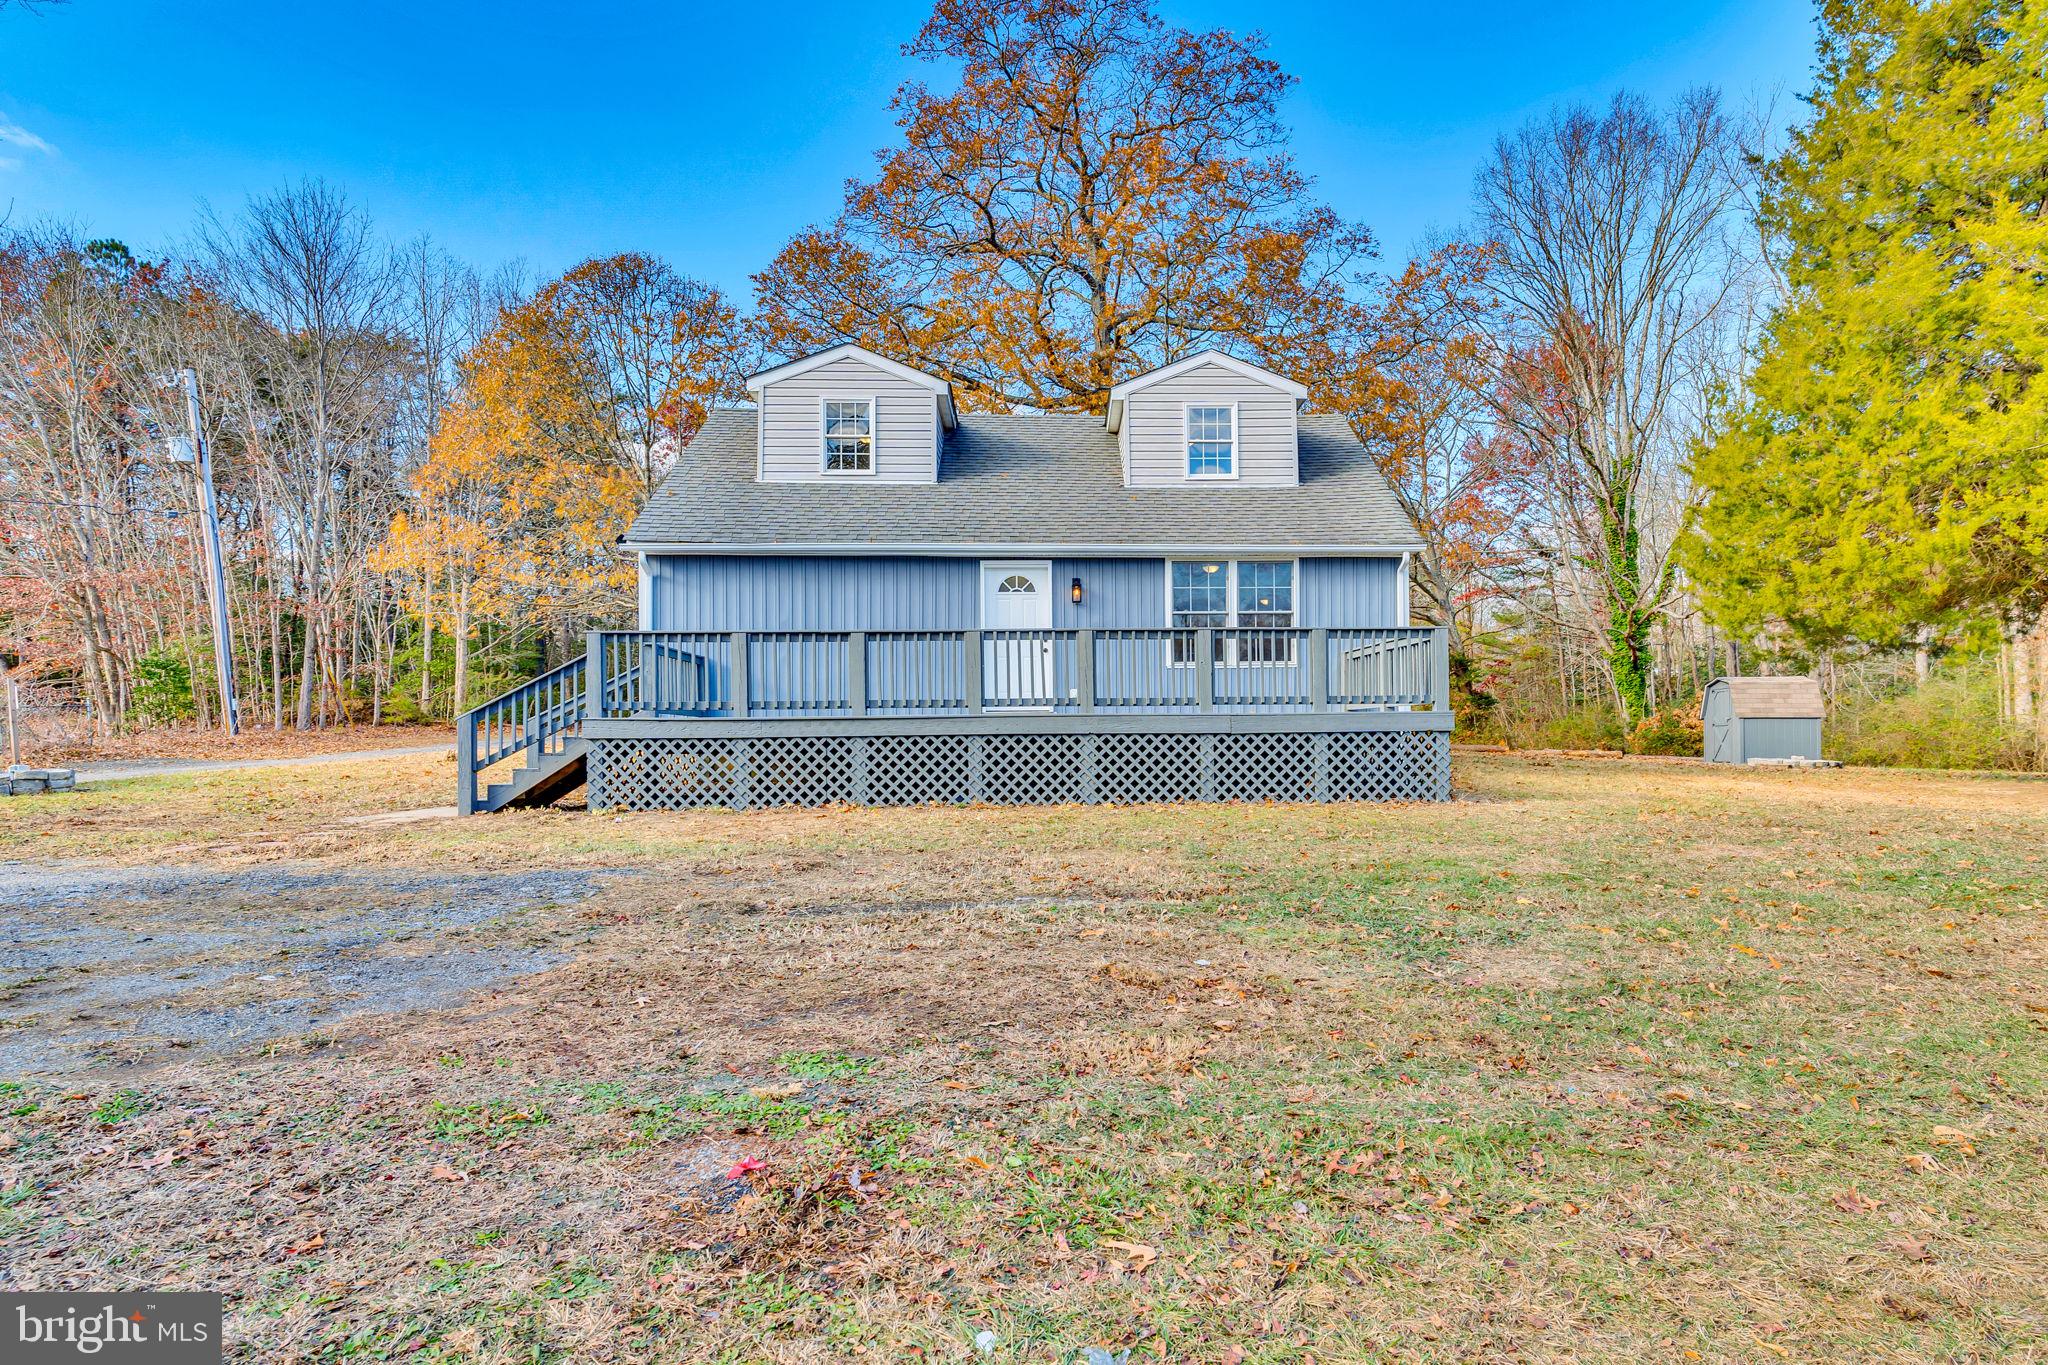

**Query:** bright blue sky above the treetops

left=0, top=0, right=1812, bottom=293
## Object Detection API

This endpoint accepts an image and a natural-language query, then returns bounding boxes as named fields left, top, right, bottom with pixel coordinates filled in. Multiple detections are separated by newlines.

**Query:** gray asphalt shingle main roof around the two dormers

left=625, top=409, right=1421, bottom=551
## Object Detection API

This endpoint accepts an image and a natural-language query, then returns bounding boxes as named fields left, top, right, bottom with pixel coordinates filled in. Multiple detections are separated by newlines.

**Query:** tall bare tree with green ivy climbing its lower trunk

left=1477, top=90, right=1745, bottom=722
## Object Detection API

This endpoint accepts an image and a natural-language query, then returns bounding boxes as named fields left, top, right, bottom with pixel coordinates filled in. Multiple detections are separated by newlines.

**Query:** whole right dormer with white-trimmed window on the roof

left=1106, top=350, right=1309, bottom=489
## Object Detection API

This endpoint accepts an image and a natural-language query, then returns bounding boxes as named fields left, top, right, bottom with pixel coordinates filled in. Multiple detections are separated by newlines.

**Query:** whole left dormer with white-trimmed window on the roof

left=748, top=342, right=956, bottom=483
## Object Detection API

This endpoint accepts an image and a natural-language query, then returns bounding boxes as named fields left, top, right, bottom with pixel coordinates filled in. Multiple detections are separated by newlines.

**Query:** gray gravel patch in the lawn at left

left=0, top=864, right=622, bottom=1078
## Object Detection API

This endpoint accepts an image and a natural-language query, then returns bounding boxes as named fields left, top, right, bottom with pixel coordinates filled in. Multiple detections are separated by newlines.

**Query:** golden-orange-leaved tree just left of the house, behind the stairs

left=381, top=256, right=745, bottom=696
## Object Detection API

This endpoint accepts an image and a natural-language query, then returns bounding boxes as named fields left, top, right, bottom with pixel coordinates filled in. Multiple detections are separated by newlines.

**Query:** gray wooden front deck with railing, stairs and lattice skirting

left=457, top=626, right=1452, bottom=812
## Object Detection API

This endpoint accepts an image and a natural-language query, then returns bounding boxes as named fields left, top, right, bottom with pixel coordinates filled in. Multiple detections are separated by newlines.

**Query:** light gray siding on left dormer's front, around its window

left=760, top=356, right=938, bottom=483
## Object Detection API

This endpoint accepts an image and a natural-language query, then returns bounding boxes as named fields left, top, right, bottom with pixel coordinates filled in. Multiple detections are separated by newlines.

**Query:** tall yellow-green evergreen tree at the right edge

left=1690, top=0, right=2048, bottom=645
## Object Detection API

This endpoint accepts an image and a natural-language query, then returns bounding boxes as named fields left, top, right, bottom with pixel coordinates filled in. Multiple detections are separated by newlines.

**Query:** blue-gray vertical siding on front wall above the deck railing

left=641, top=555, right=1403, bottom=630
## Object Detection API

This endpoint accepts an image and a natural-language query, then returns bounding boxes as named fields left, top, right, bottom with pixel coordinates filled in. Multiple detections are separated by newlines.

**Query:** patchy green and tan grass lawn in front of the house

left=0, top=757, right=2048, bottom=1363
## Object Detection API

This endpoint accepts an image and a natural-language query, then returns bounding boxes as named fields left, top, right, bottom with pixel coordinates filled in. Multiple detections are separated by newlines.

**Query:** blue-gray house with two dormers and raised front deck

left=459, top=346, right=1452, bottom=810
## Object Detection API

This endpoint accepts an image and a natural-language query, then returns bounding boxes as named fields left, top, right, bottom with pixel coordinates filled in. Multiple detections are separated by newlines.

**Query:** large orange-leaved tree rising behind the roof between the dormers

left=754, top=0, right=1376, bottom=411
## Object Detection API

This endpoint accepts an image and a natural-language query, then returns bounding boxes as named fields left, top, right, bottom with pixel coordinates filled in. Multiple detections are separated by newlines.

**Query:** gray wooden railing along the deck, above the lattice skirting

left=577, top=626, right=1450, bottom=720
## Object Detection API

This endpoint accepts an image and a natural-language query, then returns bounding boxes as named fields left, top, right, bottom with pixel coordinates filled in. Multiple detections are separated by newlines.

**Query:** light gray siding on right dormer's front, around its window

left=1120, top=364, right=1300, bottom=487
